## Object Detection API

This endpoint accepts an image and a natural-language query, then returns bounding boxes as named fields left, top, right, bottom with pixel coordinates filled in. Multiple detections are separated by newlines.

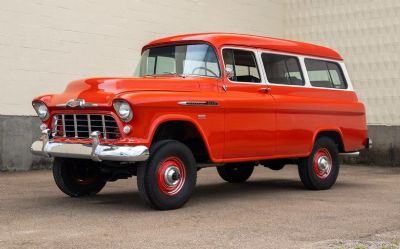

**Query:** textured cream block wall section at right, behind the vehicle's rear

left=285, top=0, right=400, bottom=125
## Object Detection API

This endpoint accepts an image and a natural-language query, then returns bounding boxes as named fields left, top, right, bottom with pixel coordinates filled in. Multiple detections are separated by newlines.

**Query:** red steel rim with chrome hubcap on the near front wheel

left=157, top=157, right=186, bottom=196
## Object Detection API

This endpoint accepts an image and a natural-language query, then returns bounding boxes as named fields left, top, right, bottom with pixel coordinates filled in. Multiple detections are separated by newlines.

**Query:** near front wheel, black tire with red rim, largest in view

left=137, top=140, right=197, bottom=210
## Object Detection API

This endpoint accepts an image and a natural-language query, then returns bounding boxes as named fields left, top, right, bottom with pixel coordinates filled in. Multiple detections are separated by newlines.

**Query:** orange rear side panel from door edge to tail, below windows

left=270, top=85, right=367, bottom=155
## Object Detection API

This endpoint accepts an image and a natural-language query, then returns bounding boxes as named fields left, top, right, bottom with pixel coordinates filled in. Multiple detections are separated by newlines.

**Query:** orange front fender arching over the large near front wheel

left=115, top=91, right=225, bottom=162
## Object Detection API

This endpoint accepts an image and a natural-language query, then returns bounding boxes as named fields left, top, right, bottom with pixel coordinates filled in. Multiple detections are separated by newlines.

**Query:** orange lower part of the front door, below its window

left=223, top=82, right=276, bottom=158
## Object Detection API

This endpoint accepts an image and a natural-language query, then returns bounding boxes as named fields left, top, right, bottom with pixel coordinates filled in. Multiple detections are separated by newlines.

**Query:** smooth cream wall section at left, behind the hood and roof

left=0, top=0, right=284, bottom=115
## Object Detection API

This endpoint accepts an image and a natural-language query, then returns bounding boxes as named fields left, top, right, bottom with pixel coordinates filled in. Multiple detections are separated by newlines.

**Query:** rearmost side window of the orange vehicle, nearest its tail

left=304, top=59, right=347, bottom=89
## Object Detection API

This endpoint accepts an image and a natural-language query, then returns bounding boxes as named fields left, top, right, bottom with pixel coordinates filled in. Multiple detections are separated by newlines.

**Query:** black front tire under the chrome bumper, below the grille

left=53, top=158, right=107, bottom=197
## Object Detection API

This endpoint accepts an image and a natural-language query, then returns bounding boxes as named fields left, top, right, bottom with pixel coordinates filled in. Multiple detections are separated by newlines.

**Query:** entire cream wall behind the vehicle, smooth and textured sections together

left=0, top=0, right=400, bottom=125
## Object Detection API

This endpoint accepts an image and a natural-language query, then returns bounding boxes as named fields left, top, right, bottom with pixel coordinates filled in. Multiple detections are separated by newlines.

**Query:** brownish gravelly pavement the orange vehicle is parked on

left=0, top=165, right=400, bottom=249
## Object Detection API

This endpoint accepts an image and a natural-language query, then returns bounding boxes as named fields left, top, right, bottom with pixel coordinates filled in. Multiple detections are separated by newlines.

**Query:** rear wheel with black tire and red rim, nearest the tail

left=298, top=137, right=340, bottom=190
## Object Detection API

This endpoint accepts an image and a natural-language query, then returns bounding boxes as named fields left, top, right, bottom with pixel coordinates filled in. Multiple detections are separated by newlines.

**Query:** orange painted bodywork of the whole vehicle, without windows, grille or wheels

left=35, top=34, right=367, bottom=163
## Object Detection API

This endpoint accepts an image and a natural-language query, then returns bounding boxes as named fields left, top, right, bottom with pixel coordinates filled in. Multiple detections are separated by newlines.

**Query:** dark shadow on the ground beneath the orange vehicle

left=37, top=179, right=360, bottom=212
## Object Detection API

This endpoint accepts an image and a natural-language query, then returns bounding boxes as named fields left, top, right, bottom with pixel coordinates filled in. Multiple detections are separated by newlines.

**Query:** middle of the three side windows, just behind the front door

left=261, top=53, right=304, bottom=86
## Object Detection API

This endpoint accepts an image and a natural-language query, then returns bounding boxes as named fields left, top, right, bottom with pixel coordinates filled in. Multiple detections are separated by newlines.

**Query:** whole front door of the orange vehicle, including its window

left=222, top=48, right=276, bottom=160
